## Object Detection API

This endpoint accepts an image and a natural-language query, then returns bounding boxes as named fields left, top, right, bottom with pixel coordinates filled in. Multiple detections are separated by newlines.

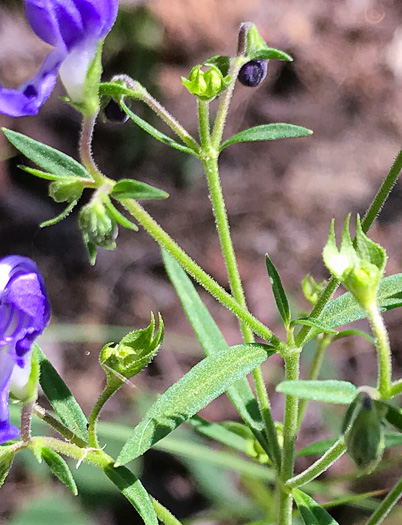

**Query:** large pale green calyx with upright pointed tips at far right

left=322, top=215, right=387, bottom=308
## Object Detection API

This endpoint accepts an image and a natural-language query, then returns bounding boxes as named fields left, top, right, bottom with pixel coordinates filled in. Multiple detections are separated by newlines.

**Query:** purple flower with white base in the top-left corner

left=0, top=0, right=119, bottom=117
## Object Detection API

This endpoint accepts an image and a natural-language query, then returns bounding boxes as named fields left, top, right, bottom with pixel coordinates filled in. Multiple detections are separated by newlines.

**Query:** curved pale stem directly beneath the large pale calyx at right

left=365, top=302, right=392, bottom=399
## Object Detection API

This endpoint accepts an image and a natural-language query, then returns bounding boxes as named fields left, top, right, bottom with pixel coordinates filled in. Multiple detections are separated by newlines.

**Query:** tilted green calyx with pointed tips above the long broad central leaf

left=99, top=315, right=164, bottom=382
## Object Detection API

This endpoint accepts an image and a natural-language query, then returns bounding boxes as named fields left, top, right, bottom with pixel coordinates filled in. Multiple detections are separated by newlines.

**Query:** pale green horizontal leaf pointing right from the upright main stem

left=276, top=380, right=357, bottom=405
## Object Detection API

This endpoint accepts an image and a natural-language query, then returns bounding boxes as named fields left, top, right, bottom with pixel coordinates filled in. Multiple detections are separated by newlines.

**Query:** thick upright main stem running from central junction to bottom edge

left=278, top=349, right=300, bottom=525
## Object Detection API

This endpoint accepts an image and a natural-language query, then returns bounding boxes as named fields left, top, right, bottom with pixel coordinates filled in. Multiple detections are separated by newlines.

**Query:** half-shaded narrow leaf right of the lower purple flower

left=36, top=345, right=88, bottom=442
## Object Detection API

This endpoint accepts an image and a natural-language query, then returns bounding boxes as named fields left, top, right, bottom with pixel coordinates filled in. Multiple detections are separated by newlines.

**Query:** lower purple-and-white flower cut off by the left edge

left=0, top=255, right=50, bottom=443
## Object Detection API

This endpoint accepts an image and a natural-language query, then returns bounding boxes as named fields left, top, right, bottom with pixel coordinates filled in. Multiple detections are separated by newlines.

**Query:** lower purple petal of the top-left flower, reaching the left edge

left=0, top=48, right=66, bottom=117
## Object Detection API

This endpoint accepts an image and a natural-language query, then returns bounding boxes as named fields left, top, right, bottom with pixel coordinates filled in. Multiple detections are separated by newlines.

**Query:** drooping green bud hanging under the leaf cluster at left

left=78, top=191, right=117, bottom=264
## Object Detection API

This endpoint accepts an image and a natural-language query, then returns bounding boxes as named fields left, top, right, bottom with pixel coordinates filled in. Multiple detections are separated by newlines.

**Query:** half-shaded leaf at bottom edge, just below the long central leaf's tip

left=104, top=466, right=158, bottom=525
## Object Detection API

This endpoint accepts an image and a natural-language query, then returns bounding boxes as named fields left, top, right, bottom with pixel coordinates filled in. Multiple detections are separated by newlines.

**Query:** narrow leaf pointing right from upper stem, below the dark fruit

left=220, top=123, right=313, bottom=151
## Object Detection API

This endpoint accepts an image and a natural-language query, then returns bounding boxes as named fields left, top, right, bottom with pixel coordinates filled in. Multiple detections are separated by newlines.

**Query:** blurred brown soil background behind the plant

left=0, top=0, right=402, bottom=525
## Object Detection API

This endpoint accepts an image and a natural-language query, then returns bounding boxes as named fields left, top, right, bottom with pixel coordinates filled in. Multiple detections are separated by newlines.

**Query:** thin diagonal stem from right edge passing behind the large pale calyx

left=296, top=150, right=402, bottom=347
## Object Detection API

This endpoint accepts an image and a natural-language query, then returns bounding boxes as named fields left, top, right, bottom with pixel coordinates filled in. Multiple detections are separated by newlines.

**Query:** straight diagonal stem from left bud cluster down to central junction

left=120, top=199, right=284, bottom=348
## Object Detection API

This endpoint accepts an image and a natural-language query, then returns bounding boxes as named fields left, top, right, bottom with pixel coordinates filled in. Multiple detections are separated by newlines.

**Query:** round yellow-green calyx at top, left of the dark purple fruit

left=181, top=64, right=232, bottom=100
